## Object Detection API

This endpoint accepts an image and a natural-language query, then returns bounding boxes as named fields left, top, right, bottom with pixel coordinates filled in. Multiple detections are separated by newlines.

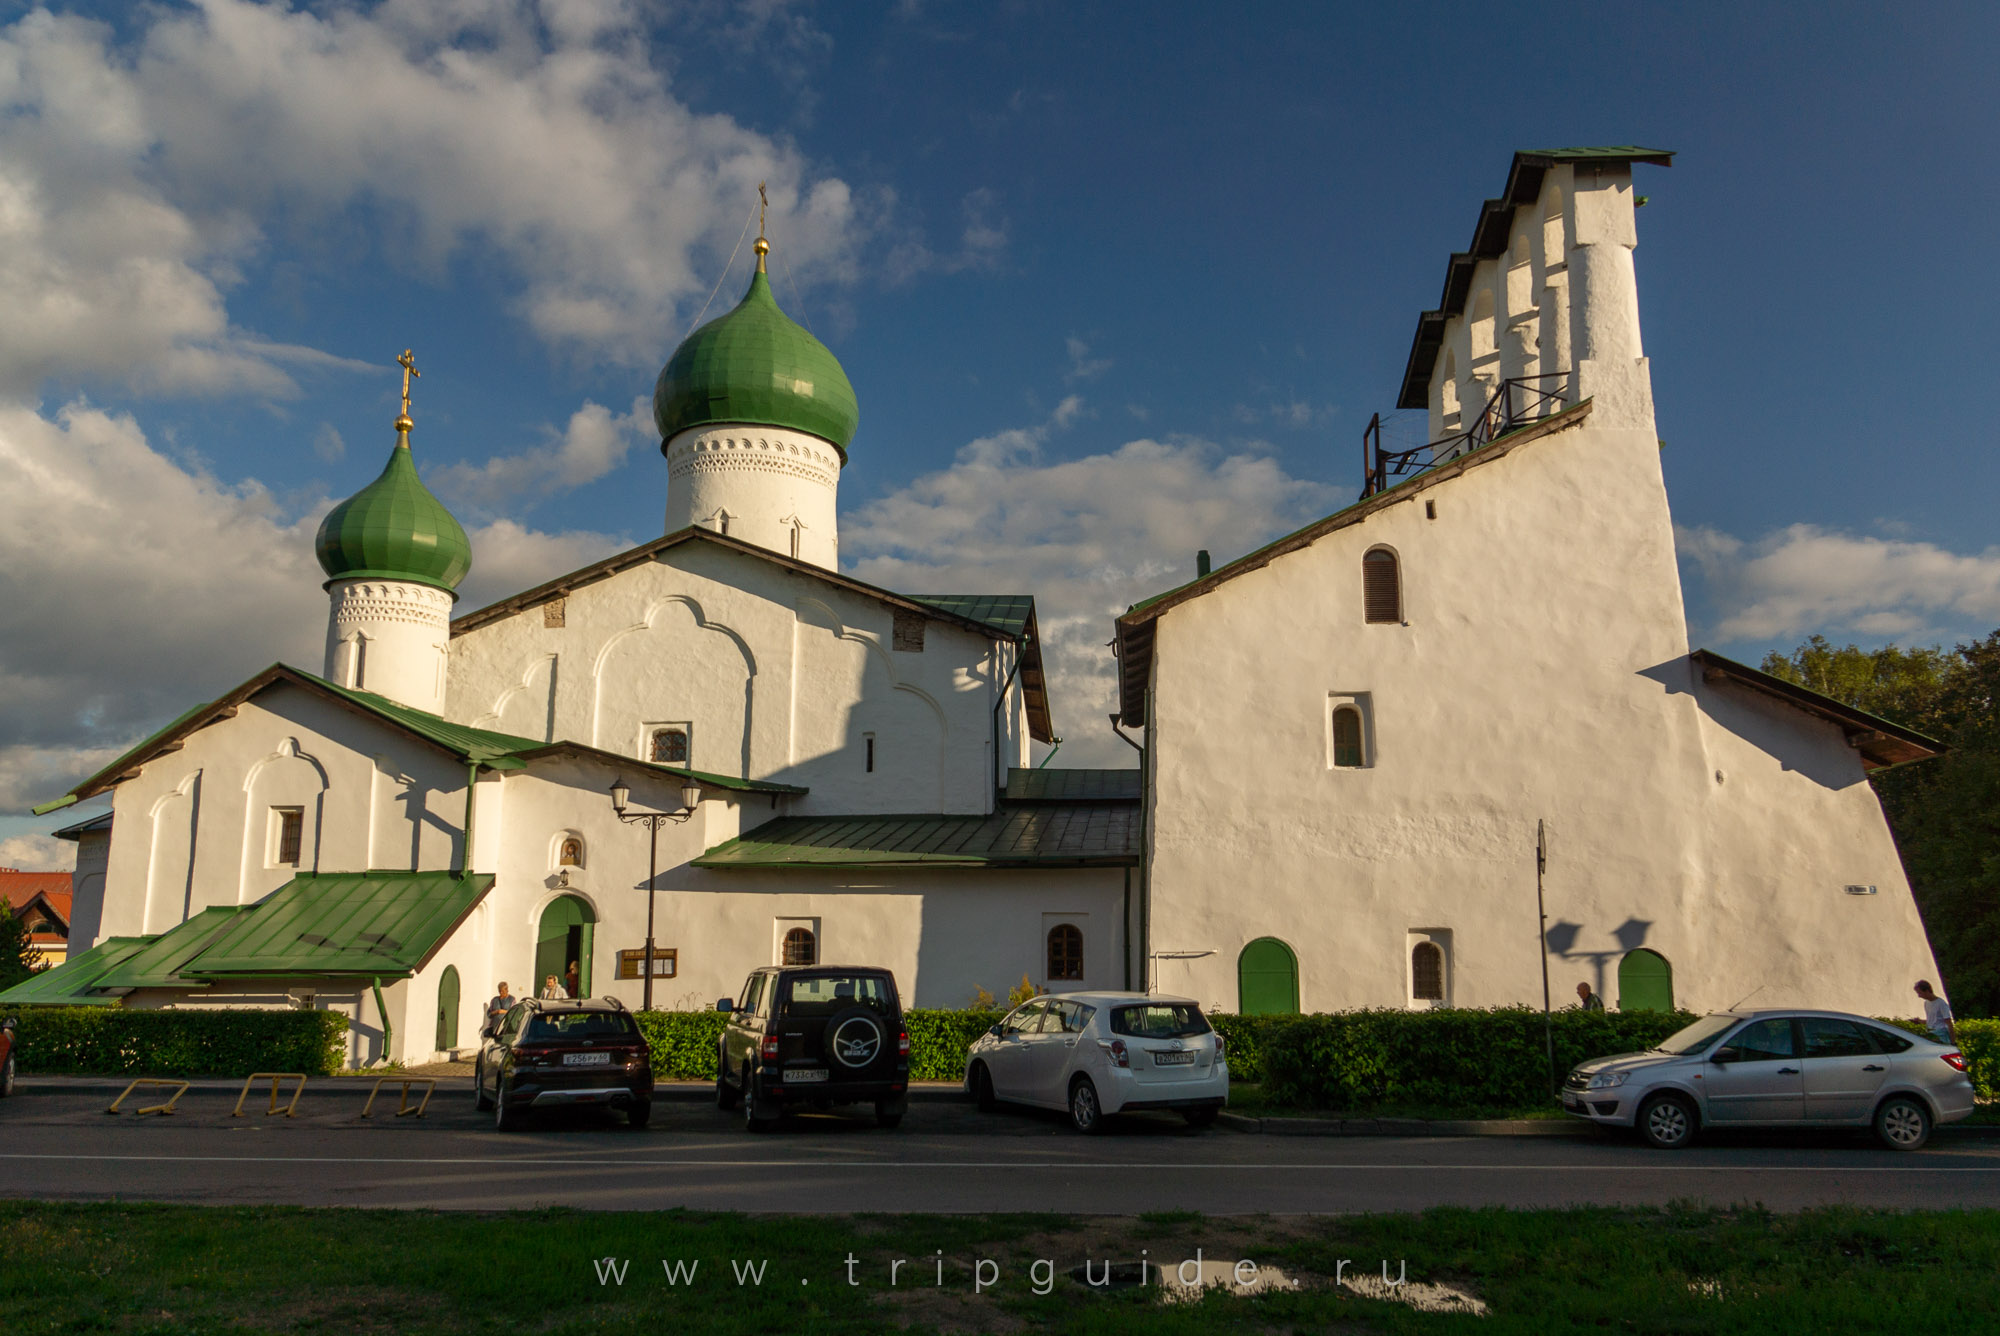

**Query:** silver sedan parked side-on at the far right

left=1562, top=1010, right=1972, bottom=1150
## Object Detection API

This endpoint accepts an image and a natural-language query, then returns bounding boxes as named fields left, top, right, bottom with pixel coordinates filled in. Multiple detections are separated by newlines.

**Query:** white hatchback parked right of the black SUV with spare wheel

left=966, top=992, right=1230, bottom=1132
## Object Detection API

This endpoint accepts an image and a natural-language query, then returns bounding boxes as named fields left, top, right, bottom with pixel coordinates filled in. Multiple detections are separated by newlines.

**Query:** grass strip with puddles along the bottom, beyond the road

left=0, top=1202, right=2000, bottom=1336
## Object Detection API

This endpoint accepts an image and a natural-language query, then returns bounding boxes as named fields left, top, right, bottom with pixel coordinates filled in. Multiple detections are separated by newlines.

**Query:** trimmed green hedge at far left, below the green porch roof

left=6, top=1006, right=348, bottom=1076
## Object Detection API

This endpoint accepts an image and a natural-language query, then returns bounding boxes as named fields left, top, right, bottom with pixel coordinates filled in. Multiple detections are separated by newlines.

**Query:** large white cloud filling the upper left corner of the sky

left=0, top=0, right=860, bottom=398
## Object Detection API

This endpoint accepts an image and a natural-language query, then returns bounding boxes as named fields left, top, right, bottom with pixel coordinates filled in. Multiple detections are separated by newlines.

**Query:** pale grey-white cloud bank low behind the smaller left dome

left=0, top=402, right=626, bottom=812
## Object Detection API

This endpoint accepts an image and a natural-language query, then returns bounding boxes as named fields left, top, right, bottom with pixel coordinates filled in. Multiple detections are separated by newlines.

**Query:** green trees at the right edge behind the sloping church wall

left=1764, top=632, right=2000, bottom=1016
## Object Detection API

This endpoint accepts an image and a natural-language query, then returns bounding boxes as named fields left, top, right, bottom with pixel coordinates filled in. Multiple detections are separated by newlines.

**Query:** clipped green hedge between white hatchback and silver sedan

left=1256, top=1006, right=1694, bottom=1110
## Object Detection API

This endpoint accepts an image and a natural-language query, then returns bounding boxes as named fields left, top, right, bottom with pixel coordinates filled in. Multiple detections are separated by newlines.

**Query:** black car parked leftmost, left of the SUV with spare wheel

left=472, top=998, right=652, bottom=1132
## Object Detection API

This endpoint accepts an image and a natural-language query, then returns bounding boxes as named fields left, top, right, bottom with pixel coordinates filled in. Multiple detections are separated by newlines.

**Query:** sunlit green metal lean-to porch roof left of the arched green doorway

left=180, top=872, right=494, bottom=978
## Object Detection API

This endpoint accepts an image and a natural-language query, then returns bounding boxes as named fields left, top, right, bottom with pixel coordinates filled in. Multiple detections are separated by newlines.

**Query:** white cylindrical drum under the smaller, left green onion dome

left=324, top=580, right=452, bottom=714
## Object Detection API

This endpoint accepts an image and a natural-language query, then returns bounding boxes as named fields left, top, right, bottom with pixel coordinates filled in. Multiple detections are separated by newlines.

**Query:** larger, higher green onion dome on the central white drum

left=652, top=266, right=860, bottom=458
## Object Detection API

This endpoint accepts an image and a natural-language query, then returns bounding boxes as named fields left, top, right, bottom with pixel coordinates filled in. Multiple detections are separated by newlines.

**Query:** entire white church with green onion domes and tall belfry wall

left=4, top=148, right=1938, bottom=1062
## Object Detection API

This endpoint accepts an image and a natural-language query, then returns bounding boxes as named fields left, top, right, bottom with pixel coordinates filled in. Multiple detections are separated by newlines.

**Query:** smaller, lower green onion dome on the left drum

left=312, top=438, right=472, bottom=592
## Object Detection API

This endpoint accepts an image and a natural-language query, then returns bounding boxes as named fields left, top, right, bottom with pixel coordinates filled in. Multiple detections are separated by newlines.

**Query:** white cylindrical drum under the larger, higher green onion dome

left=662, top=422, right=840, bottom=570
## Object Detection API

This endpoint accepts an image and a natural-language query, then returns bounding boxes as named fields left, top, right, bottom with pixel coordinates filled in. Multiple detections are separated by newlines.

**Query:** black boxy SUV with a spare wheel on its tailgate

left=716, top=966, right=910, bottom=1132
